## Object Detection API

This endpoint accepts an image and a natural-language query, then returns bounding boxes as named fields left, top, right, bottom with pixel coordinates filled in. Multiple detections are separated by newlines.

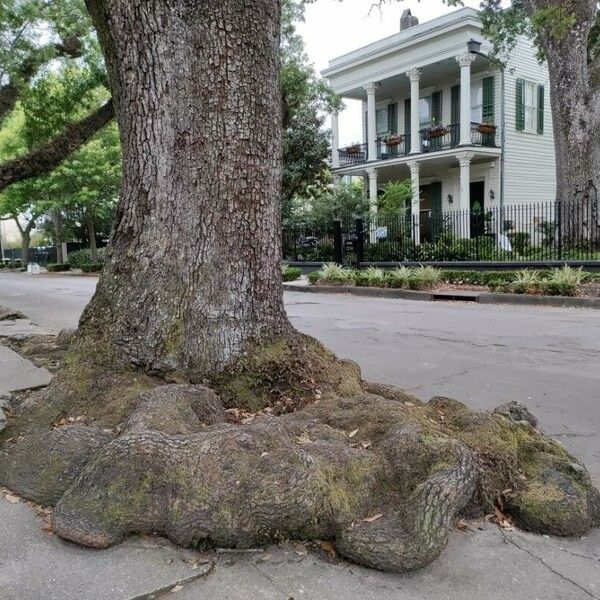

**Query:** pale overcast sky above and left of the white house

left=298, top=0, right=480, bottom=146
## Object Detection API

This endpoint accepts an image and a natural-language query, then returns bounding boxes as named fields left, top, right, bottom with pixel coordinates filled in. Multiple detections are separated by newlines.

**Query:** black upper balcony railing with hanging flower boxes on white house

left=338, top=123, right=497, bottom=167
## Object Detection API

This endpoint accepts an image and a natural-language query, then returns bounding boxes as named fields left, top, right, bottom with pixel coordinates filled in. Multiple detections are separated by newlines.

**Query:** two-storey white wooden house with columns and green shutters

left=323, top=8, right=556, bottom=239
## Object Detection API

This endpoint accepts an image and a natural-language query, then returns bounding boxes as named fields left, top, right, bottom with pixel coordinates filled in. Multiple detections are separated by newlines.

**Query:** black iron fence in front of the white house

left=283, top=202, right=600, bottom=264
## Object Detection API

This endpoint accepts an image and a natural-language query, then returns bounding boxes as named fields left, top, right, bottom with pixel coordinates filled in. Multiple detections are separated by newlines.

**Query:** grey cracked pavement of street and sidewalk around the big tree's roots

left=0, top=273, right=600, bottom=600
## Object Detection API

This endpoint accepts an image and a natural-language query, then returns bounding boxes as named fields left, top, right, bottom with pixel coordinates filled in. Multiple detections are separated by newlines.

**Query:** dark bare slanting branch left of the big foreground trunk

left=0, top=100, right=114, bottom=190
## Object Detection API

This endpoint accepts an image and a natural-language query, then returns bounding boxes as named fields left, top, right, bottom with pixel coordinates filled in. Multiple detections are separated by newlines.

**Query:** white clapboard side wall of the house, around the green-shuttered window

left=504, top=37, right=556, bottom=204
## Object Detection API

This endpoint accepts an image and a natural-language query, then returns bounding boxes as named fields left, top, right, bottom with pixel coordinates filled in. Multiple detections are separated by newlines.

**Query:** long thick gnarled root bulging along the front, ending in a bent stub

left=54, top=390, right=475, bottom=571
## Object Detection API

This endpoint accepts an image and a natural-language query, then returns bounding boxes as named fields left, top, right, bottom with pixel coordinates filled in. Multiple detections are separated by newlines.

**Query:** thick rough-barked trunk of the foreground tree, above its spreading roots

left=79, top=0, right=288, bottom=377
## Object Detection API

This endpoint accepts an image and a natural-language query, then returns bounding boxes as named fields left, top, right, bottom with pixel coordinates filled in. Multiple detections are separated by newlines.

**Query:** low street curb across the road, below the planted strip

left=283, top=283, right=600, bottom=309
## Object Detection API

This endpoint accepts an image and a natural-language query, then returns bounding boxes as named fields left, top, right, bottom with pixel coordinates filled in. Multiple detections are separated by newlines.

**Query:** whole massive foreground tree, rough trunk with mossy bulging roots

left=0, top=0, right=600, bottom=571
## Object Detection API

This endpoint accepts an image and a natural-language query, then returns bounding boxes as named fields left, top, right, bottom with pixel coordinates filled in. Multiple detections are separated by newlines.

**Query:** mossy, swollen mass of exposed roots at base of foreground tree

left=0, top=338, right=600, bottom=571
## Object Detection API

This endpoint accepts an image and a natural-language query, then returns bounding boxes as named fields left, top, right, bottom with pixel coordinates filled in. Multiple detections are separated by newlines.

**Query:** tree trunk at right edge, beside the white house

left=524, top=0, right=600, bottom=245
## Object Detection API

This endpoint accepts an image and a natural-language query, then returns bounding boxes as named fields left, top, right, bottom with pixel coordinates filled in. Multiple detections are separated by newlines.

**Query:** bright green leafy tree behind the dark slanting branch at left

left=0, top=65, right=114, bottom=265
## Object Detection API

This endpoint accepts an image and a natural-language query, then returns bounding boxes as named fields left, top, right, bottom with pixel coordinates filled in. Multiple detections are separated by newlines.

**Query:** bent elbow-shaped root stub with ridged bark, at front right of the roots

left=336, top=428, right=476, bottom=572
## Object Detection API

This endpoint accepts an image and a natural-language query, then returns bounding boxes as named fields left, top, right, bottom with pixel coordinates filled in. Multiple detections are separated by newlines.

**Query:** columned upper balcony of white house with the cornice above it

left=324, top=9, right=502, bottom=172
